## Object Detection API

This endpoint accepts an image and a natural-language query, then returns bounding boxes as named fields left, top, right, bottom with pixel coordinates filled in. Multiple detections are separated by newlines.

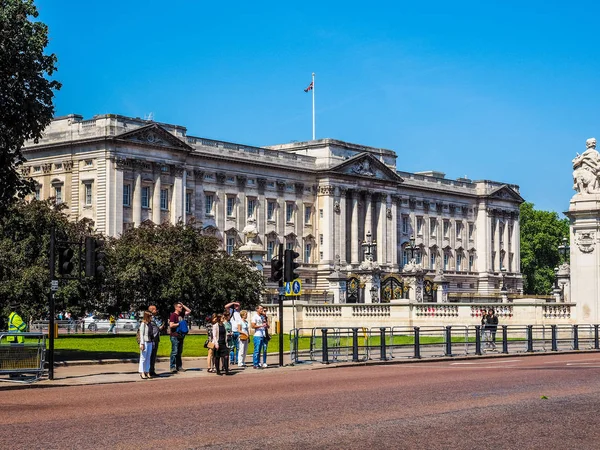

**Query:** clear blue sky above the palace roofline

left=36, top=0, right=600, bottom=212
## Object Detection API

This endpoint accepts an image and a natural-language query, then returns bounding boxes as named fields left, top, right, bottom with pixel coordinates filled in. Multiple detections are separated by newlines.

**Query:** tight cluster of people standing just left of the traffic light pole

left=205, top=302, right=270, bottom=375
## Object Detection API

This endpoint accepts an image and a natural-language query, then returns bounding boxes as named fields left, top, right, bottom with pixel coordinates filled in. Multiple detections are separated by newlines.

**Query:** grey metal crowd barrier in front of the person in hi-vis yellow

left=0, top=333, right=46, bottom=383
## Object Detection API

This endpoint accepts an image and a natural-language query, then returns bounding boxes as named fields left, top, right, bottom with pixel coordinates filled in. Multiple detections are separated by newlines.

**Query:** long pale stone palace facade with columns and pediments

left=23, top=114, right=523, bottom=297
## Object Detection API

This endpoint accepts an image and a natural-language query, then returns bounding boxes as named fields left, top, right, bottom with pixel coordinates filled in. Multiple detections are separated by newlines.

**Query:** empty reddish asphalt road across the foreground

left=0, top=353, right=600, bottom=450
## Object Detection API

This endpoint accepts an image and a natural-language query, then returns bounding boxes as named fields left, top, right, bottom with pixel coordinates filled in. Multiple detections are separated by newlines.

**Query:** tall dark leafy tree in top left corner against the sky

left=0, top=0, right=61, bottom=214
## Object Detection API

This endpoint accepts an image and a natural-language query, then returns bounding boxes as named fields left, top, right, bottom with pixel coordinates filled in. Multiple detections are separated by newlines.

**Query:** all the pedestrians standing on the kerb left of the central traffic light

left=138, top=302, right=270, bottom=379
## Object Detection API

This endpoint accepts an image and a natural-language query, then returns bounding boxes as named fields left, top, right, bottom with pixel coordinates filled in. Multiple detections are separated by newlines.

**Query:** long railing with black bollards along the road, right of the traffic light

left=290, top=324, right=600, bottom=364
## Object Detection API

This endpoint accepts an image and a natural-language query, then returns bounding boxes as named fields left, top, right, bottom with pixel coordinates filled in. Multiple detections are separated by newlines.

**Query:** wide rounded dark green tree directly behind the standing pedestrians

left=103, top=222, right=264, bottom=319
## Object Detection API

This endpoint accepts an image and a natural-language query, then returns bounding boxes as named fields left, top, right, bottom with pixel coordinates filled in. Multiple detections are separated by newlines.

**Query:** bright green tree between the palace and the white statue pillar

left=521, top=202, right=569, bottom=295
